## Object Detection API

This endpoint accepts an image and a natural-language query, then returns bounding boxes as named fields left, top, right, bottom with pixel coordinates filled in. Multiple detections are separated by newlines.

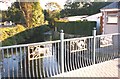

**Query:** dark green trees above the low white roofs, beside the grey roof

left=60, top=2, right=111, bottom=17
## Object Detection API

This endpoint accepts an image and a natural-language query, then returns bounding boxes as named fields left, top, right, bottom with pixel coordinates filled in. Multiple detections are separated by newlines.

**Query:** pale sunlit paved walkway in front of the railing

left=54, top=58, right=120, bottom=78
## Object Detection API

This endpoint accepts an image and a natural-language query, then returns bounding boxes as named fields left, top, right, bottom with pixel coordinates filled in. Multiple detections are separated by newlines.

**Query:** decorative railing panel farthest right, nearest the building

left=100, top=35, right=113, bottom=47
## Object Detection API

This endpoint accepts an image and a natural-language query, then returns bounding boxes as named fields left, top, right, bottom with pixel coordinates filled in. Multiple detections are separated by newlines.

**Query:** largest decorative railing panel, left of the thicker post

left=28, top=45, right=52, bottom=60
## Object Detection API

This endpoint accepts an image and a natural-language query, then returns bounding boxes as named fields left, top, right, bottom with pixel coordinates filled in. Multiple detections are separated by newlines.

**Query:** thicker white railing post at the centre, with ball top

left=60, top=30, right=64, bottom=73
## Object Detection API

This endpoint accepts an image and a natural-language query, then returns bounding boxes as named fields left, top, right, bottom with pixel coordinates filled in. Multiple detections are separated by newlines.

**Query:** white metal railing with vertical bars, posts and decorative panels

left=0, top=29, right=120, bottom=78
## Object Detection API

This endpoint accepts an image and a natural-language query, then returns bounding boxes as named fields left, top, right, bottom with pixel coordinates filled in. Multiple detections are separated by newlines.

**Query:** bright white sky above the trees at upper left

left=0, top=0, right=67, bottom=10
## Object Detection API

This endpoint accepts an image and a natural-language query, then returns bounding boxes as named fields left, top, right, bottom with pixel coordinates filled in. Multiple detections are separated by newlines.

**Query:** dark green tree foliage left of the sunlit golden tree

left=1, top=2, right=25, bottom=23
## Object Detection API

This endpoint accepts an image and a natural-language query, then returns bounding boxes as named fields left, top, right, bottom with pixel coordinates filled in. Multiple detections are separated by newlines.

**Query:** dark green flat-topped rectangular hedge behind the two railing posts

left=55, top=21, right=96, bottom=36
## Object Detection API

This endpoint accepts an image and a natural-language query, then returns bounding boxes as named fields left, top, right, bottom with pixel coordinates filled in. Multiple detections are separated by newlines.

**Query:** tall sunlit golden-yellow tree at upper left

left=19, top=2, right=44, bottom=28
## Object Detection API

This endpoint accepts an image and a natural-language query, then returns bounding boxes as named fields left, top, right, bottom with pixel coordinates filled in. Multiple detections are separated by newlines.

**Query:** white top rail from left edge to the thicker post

left=0, top=40, right=60, bottom=49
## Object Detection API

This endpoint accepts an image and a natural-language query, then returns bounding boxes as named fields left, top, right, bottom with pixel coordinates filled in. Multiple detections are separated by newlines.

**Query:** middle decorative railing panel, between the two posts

left=70, top=39, right=87, bottom=53
